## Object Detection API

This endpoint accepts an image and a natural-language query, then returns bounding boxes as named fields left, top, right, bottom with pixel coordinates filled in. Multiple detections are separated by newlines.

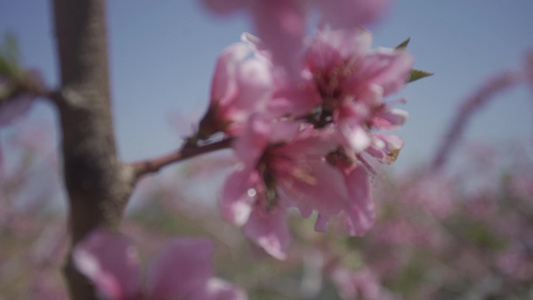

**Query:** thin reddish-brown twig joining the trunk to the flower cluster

left=131, top=138, right=233, bottom=177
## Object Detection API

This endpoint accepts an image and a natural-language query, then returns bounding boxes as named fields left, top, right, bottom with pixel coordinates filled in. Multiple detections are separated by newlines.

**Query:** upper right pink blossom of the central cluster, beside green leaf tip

left=305, top=28, right=413, bottom=155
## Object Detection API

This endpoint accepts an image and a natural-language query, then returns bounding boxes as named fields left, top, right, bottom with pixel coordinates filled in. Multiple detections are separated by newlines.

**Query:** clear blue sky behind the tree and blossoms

left=0, top=0, right=533, bottom=172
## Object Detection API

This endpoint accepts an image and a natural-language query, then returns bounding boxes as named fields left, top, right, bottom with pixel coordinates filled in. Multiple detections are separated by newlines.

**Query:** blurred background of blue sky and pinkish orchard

left=0, top=0, right=533, bottom=300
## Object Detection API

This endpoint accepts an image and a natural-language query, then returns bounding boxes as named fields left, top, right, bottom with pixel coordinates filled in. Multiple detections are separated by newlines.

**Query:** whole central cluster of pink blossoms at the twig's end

left=197, top=26, right=413, bottom=259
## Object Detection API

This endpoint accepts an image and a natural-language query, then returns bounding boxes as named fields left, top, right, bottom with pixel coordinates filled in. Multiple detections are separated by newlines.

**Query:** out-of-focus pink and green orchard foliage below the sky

left=0, top=125, right=533, bottom=300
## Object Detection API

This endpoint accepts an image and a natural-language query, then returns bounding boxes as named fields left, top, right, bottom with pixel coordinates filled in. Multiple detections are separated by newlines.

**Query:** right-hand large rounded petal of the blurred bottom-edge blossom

left=147, top=238, right=214, bottom=299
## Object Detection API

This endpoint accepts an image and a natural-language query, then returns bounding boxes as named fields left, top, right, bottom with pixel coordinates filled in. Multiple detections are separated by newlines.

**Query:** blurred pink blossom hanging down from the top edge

left=203, top=0, right=388, bottom=74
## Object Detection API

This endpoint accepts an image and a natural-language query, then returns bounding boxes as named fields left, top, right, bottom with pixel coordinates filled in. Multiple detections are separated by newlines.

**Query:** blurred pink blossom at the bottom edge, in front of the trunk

left=73, top=231, right=247, bottom=300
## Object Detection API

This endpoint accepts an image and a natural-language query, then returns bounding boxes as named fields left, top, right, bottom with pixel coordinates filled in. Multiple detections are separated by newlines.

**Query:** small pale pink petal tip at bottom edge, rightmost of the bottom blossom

left=190, top=278, right=248, bottom=300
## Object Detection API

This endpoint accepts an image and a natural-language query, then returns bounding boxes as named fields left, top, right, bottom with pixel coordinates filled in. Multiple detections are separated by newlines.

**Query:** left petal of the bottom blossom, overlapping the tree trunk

left=72, top=230, right=140, bottom=300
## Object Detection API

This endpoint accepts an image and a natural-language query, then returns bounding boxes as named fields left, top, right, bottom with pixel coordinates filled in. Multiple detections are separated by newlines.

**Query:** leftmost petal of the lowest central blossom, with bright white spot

left=219, top=170, right=260, bottom=226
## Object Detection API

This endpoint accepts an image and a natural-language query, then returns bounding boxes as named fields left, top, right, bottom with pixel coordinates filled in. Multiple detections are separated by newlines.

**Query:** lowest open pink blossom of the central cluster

left=220, top=115, right=374, bottom=259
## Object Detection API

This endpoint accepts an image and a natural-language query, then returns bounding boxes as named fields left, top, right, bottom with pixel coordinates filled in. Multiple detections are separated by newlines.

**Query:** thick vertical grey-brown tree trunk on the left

left=53, top=0, right=134, bottom=300
